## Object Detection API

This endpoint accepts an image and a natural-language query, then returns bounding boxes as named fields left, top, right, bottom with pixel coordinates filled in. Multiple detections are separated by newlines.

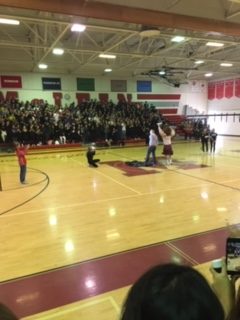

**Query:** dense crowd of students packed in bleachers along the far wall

left=0, top=100, right=161, bottom=145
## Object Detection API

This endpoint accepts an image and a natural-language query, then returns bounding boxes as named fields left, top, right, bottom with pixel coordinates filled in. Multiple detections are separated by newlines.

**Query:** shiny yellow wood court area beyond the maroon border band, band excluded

left=0, top=137, right=240, bottom=281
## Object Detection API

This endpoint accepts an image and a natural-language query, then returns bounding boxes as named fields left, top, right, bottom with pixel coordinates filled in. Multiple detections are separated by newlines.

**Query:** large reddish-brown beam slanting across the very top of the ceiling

left=0, top=0, right=240, bottom=36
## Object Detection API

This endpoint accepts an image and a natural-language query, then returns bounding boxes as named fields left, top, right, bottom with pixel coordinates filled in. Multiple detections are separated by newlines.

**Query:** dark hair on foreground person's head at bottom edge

left=120, top=263, right=224, bottom=320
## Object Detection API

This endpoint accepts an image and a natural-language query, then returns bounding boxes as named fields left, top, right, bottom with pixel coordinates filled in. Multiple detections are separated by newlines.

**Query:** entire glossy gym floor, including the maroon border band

left=0, top=137, right=240, bottom=320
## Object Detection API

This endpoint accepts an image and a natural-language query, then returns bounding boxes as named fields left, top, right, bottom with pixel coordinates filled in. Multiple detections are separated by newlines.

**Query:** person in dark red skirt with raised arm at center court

left=157, top=122, right=175, bottom=166
